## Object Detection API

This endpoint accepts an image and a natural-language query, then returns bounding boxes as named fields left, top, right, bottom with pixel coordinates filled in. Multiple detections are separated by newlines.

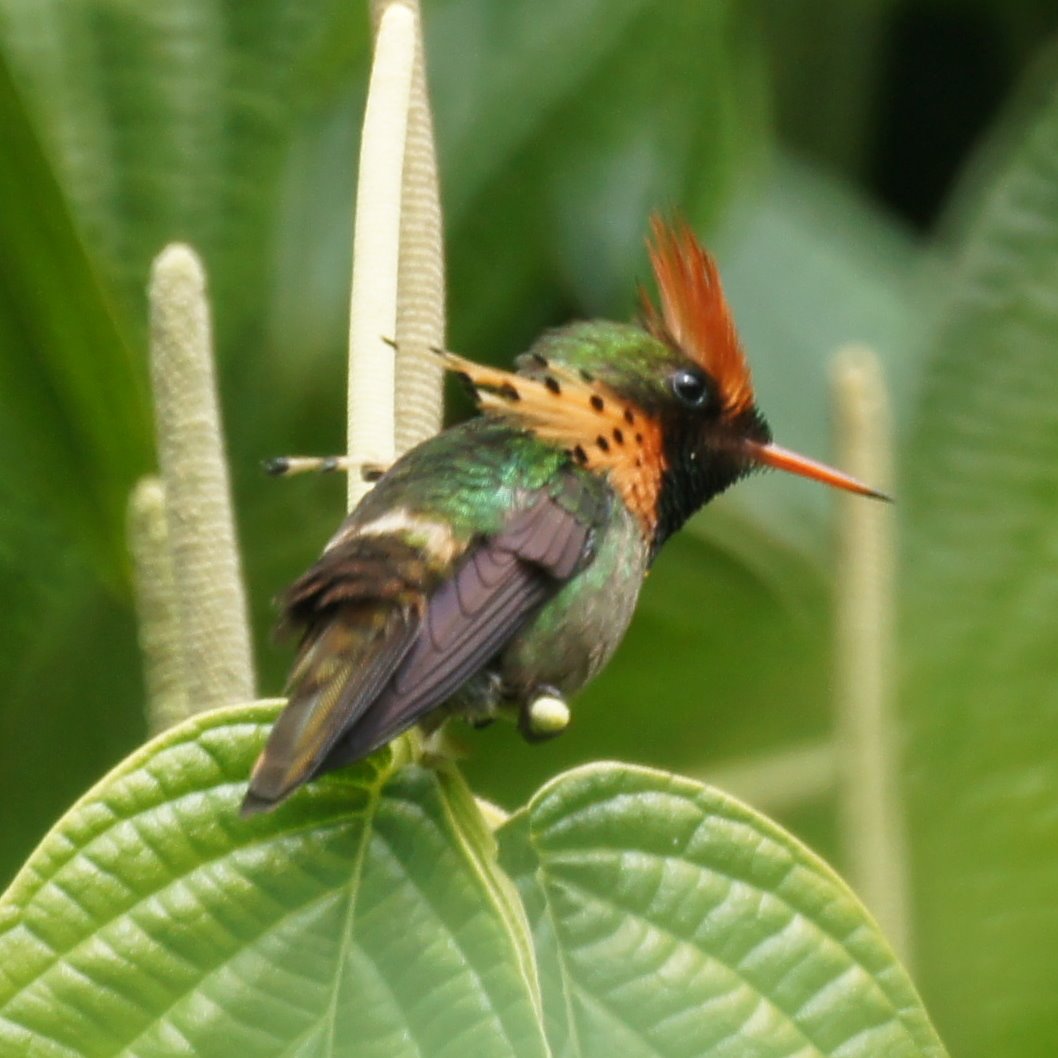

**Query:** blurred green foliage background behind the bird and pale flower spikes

left=0, top=0, right=1058, bottom=1058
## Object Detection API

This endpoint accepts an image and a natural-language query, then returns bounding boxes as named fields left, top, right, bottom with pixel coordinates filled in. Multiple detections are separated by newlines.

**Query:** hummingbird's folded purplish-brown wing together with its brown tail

left=243, top=475, right=598, bottom=811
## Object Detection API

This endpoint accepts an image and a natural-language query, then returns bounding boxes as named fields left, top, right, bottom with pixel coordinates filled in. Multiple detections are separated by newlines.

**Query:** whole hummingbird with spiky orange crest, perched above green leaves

left=242, top=216, right=888, bottom=815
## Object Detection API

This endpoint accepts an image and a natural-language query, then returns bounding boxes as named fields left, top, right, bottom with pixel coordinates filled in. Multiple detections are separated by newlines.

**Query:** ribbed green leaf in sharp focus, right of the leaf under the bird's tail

left=498, top=764, right=945, bottom=1058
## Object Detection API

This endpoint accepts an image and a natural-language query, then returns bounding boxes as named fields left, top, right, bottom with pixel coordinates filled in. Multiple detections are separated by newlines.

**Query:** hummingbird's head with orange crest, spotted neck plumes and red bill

left=435, top=216, right=884, bottom=547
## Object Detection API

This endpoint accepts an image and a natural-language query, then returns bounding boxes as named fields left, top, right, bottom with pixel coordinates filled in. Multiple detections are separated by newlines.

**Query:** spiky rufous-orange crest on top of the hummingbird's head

left=642, top=214, right=753, bottom=415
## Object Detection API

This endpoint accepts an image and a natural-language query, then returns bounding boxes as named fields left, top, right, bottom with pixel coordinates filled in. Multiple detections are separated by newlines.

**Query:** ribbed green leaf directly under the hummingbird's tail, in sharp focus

left=0, top=705, right=547, bottom=1058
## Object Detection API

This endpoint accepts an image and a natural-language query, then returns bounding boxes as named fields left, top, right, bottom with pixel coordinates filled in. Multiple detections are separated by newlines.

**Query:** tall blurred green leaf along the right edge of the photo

left=905, top=60, right=1058, bottom=1058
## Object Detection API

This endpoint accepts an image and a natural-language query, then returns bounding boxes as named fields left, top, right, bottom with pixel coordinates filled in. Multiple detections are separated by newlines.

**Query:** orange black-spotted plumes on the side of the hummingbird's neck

left=442, top=352, right=665, bottom=539
